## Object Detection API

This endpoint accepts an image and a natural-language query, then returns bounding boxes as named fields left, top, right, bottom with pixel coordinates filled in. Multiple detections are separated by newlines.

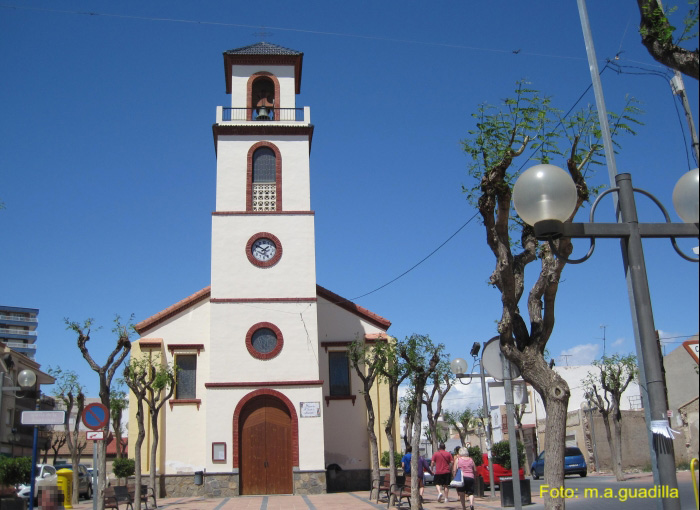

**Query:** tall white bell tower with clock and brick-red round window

left=206, top=42, right=324, bottom=494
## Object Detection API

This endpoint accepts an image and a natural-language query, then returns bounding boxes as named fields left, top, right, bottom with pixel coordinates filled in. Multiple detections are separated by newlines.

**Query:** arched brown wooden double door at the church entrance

left=238, top=395, right=293, bottom=494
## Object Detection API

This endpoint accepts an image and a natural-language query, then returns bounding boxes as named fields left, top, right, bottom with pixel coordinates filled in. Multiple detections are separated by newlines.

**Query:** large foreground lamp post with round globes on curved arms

left=513, top=164, right=698, bottom=510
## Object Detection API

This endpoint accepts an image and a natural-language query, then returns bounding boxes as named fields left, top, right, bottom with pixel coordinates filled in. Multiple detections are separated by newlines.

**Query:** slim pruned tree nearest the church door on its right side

left=348, top=338, right=387, bottom=496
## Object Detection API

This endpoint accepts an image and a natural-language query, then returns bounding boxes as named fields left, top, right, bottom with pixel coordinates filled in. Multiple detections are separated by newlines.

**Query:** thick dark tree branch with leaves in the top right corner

left=637, top=0, right=700, bottom=80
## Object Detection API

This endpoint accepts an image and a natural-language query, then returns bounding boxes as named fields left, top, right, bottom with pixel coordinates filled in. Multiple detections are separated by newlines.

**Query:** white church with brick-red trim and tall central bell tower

left=129, top=42, right=399, bottom=496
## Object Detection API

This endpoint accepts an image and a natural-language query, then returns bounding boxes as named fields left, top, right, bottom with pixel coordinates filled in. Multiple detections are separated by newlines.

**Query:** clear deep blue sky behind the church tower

left=0, top=0, right=698, bottom=405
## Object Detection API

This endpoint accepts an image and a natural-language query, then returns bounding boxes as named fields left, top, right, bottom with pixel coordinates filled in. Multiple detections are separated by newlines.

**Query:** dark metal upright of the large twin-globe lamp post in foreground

left=615, top=174, right=681, bottom=510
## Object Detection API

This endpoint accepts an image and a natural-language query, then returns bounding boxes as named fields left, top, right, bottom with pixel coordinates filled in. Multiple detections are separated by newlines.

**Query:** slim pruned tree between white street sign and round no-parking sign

left=49, top=367, right=87, bottom=505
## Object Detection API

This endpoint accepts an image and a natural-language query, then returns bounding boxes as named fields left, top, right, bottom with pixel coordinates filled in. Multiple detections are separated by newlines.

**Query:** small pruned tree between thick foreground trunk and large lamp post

left=583, top=354, right=639, bottom=481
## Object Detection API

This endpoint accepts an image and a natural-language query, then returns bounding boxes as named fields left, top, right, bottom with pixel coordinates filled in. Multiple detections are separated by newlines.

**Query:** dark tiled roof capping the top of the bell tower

left=224, top=42, right=304, bottom=94
